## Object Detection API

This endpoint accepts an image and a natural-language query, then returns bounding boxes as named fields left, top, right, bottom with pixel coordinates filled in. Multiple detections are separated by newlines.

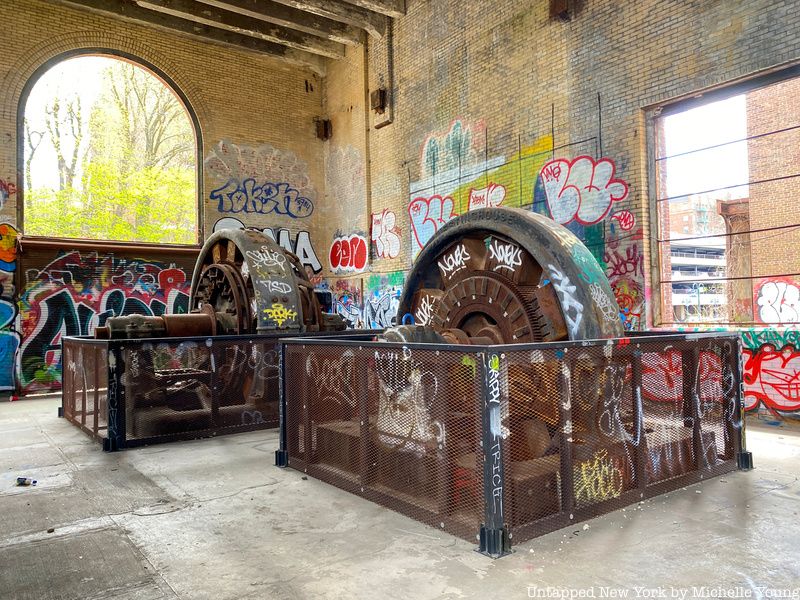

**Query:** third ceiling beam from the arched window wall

left=198, top=0, right=364, bottom=46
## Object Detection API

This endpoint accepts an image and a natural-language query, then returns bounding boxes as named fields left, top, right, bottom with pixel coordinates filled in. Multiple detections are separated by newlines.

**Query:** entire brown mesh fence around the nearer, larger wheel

left=278, top=334, right=743, bottom=556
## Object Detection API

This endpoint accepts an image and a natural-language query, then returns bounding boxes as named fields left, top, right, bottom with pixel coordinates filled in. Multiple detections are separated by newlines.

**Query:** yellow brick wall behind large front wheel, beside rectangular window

left=360, top=0, right=800, bottom=328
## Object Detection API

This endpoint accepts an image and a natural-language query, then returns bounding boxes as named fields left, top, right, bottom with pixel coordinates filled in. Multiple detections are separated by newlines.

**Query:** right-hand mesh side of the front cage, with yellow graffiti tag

left=500, top=339, right=739, bottom=541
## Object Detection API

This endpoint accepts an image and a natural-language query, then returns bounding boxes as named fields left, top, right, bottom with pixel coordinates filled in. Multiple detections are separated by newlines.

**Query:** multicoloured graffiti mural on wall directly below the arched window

left=19, top=251, right=189, bottom=391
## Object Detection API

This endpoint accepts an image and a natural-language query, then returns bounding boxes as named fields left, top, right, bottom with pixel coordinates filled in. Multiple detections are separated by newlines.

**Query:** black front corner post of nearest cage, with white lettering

left=478, top=350, right=511, bottom=558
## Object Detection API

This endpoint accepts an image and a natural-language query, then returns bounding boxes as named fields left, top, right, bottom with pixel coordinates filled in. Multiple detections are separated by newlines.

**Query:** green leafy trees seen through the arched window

left=25, top=60, right=197, bottom=244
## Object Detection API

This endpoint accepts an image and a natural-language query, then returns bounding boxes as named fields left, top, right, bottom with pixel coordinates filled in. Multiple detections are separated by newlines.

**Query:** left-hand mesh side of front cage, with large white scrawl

left=285, top=344, right=483, bottom=540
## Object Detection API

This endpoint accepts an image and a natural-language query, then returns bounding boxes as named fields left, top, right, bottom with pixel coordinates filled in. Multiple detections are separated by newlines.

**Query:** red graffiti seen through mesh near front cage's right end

left=642, top=349, right=722, bottom=402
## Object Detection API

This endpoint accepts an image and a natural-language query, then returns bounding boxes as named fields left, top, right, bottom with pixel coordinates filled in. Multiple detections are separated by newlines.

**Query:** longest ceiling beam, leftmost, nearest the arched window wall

left=51, top=0, right=326, bottom=74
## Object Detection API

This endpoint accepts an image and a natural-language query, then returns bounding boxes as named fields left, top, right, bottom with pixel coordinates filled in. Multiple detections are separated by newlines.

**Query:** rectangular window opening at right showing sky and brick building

left=655, top=78, right=800, bottom=326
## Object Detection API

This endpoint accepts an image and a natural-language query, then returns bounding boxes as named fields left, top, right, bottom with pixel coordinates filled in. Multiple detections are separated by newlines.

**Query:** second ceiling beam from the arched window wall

left=136, top=0, right=344, bottom=58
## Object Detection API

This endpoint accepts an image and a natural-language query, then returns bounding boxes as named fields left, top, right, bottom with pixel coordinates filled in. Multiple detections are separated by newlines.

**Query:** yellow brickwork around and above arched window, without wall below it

left=0, top=0, right=325, bottom=241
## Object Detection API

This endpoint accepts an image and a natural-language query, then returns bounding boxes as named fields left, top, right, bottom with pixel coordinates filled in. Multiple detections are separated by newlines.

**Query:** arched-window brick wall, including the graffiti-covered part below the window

left=0, top=0, right=324, bottom=390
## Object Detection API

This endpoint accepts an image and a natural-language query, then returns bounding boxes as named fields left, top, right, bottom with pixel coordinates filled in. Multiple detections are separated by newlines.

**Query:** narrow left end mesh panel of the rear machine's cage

left=62, top=339, right=108, bottom=439
